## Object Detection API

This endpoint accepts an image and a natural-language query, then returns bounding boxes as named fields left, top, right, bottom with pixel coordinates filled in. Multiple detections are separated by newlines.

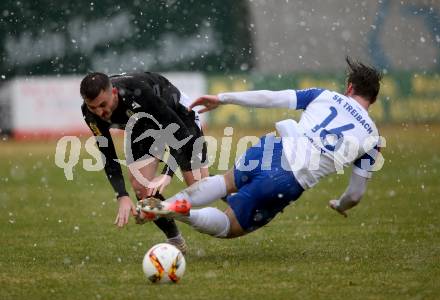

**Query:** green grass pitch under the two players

left=0, top=125, right=440, bottom=299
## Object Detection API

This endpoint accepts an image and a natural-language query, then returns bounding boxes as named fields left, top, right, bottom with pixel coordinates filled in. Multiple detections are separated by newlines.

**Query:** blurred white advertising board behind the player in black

left=0, top=73, right=206, bottom=139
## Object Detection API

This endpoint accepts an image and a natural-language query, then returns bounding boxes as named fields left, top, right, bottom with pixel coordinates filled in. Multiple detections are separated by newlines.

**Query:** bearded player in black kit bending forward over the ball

left=80, top=72, right=208, bottom=251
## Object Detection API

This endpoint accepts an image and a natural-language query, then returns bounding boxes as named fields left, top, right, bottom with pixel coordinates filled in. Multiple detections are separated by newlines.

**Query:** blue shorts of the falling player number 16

left=227, top=135, right=304, bottom=232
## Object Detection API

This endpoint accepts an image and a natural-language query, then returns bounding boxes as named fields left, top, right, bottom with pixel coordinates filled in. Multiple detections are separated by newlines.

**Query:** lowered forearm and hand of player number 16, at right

left=329, top=173, right=368, bottom=217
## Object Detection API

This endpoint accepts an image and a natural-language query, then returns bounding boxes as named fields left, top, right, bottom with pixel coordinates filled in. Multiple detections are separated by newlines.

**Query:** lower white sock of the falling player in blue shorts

left=176, top=207, right=230, bottom=238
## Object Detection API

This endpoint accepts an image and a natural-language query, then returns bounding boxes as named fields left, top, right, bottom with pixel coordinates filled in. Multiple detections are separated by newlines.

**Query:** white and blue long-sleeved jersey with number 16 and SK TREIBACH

left=218, top=88, right=379, bottom=189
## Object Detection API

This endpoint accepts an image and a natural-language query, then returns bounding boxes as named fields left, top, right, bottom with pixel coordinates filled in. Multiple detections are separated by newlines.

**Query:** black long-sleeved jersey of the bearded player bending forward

left=81, top=72, right=198, bottom=197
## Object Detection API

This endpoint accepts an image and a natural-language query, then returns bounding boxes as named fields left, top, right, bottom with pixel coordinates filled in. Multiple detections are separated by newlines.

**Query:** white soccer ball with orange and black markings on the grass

left=142, top=243, right=186, bottom=283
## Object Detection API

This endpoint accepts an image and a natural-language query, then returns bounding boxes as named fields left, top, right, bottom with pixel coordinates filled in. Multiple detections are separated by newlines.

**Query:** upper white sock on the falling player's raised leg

left=166, top=175, right=226, bottom=206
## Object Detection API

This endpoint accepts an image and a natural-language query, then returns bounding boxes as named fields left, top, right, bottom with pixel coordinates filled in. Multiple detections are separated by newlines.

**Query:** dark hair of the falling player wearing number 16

left=345, top=56, right=382, bottom=104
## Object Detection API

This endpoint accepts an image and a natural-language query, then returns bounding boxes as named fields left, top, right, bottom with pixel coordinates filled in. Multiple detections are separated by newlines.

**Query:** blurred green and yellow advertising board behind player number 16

left=208, top=72, right=440, bottom=127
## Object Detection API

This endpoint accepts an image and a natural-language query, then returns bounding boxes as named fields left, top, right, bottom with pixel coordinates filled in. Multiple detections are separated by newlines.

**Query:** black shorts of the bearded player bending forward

left=131, top=105, right=208, bottom=171
